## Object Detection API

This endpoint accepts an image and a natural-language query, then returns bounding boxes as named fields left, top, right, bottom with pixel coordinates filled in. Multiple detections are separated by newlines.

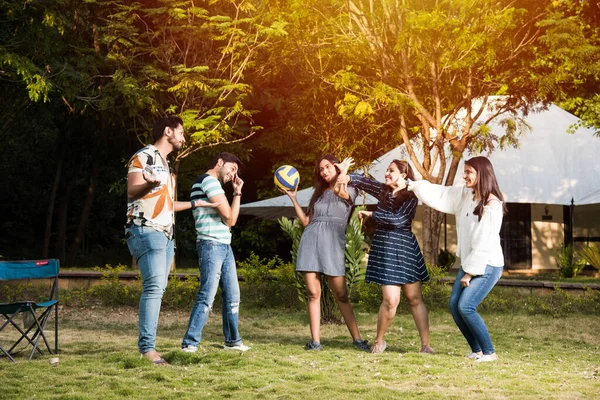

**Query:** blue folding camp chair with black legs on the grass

left=0, top=260, right=58, bottom=362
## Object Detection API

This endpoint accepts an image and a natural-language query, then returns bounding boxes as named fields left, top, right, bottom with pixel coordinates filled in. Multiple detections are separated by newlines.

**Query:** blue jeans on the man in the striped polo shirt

left=182, top=240, right=242, bottom=347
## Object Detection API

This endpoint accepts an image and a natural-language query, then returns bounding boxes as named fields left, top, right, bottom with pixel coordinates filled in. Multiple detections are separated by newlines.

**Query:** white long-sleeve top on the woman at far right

left=409, top=180, right=504, bottom=275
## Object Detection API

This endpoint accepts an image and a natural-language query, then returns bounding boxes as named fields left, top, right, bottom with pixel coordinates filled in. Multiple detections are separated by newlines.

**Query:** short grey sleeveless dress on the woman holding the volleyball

left=296, top=187, right=357, bottom=276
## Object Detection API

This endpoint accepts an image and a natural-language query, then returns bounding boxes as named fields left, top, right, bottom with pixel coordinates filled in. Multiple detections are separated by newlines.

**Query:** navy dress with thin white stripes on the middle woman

left=349, top=174, right=429, bottom=285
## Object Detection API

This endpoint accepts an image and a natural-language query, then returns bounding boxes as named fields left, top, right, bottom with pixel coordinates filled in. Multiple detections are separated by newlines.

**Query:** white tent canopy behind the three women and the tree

left=241, top=105, right=600, bottom=218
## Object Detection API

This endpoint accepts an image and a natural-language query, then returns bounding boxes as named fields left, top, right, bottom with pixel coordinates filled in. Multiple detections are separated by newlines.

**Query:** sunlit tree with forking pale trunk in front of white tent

left=310, top=0, right=539, bottom=262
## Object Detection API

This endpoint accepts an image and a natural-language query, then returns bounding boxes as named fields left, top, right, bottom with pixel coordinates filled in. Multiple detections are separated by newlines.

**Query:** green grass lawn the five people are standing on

left=0, top=307, right=600, bottom=399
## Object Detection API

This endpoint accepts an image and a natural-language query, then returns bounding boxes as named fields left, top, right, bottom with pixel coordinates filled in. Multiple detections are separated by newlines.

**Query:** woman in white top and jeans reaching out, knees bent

left=408, top=157, right=506, bottom=362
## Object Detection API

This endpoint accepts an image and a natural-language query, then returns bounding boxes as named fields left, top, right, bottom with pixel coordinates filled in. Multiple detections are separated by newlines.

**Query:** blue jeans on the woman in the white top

left=450, top=265, right=503, bottom=354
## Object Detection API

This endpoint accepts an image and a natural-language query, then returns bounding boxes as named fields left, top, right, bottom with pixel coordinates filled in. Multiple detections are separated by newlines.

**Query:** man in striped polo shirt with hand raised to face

left=181, top=153, right=249, bottom=353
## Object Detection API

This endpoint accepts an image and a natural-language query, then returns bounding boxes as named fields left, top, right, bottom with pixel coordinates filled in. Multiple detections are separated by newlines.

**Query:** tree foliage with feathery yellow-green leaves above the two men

left=101, top=0, right=285, bottom=160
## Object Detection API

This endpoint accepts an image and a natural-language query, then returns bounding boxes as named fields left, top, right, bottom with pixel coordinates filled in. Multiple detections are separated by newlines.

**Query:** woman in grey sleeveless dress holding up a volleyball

left=281, top=155, right=369, bottom=351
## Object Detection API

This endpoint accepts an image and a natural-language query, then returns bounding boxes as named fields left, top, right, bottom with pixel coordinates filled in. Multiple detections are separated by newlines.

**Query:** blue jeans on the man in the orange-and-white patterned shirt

left=126, top=226, right=174, bottom=354
